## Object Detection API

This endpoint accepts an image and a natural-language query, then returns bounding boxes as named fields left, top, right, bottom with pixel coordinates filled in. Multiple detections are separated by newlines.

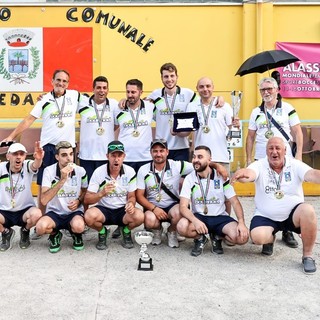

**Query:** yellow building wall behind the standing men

left=0, top=2, right=320, bottom=195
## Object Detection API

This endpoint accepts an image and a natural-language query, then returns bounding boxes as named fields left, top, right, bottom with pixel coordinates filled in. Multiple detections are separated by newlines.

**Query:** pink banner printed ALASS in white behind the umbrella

left=276, top=42, right=320, bottom=98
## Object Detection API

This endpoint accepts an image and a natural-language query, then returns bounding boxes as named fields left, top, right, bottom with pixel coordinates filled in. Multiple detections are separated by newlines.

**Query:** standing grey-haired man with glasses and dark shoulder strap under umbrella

left=246, top=77, right=303, bottom=248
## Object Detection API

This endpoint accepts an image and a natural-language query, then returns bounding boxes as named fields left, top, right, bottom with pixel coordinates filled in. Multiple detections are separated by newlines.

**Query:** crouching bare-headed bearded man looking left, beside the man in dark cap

left=177, top=146, right=249, bottom=256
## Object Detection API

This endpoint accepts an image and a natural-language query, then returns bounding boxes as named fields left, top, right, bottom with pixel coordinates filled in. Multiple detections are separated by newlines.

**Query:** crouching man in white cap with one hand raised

left=0, top=141, right=44, bottom=251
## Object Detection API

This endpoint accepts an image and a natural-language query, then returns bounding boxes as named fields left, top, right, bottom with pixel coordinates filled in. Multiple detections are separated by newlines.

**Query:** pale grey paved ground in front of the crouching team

left=0, top=197, right=320, bottom=320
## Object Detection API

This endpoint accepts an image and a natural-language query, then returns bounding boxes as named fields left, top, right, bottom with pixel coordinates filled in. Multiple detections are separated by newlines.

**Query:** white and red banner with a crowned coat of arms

left=0, top=28, right=93, bottom=92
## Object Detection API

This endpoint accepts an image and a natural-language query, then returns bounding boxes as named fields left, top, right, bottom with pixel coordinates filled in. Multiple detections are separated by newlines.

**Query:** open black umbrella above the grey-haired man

left=235, top=50, right=300, bottom=77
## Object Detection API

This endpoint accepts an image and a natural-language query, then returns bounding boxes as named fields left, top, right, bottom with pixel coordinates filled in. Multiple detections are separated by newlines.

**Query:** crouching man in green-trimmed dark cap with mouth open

left=84, top=140, right=144, bottom=250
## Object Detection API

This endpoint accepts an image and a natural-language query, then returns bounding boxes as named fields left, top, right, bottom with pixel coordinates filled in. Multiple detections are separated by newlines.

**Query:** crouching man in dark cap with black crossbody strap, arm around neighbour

left=136, top=139, right=227, bottom=248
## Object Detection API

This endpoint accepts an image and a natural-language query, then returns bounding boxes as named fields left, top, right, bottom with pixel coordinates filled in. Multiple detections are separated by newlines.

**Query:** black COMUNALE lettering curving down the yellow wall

left=66, top=7, right=154, bottom=52
